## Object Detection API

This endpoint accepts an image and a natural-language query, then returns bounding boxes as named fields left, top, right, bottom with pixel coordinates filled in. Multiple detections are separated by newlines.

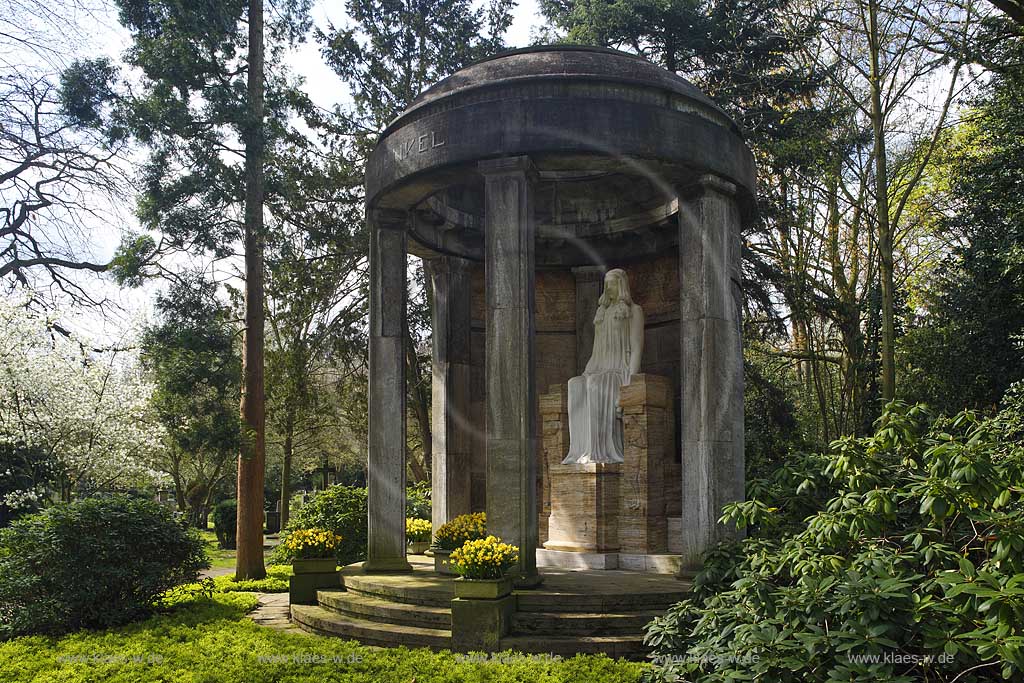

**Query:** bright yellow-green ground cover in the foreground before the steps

left=0, top=593, right=646, bottom=683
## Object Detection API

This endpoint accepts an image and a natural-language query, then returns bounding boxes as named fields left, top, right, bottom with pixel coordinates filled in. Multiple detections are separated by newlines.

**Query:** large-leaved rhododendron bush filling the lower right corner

left=647, top=403, right=1024, bottom=683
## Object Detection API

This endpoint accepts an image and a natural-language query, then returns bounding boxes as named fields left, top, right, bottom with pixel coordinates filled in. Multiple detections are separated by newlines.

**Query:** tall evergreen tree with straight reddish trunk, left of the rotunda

left=106, top=0, right=312, bottom=579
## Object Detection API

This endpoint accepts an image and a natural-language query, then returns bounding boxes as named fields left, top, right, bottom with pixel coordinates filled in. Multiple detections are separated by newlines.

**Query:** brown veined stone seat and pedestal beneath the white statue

left=540, top=374, right=678, bottom=570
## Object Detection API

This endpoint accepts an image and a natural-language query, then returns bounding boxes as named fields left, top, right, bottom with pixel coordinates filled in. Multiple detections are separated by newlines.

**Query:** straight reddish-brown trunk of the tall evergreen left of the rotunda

left=234, top=0, right=266, bottom=580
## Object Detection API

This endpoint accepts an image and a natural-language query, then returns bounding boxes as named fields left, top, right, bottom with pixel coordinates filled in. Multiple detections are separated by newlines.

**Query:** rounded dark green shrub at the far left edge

left=0, top=496, right=208, bottom=637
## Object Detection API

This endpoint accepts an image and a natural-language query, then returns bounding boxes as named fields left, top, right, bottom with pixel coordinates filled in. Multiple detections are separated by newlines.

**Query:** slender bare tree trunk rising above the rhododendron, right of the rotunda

left=867, top=0, right=896, bottom=402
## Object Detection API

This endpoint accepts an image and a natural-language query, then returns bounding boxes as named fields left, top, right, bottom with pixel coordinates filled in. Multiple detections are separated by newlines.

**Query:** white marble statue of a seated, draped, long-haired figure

left=562, top=268, right=643, bottom=465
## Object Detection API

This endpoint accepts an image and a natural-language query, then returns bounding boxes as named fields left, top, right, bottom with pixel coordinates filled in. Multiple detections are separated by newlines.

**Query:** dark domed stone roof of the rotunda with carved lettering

left=366, top=46, right=756, bottom=265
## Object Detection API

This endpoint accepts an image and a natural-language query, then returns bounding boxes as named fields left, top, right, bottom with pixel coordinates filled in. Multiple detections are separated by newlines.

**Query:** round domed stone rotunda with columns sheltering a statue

left=292, top=46, right=755, bottom=651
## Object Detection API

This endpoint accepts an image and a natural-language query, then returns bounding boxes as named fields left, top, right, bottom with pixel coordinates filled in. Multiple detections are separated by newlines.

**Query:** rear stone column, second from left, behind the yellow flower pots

left=425, top=256, right=472, bottom=529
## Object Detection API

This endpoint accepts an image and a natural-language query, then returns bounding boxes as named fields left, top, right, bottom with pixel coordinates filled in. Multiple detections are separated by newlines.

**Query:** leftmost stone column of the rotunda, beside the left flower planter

left=362, top=211, right=413, bottom=571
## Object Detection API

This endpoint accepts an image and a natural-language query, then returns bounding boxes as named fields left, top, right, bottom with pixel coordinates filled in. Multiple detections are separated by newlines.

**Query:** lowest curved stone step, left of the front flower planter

left=292, top=605, right=452, bottom=650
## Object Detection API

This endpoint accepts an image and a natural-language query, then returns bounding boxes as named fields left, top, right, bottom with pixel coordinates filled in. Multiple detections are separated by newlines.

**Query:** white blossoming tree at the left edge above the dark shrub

left=0, top=299, right=164, bottom=503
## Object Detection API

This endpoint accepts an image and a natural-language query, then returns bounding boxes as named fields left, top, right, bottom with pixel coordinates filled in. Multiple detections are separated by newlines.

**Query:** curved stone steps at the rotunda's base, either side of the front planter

left=291, top=555, right=689, bottom=659
